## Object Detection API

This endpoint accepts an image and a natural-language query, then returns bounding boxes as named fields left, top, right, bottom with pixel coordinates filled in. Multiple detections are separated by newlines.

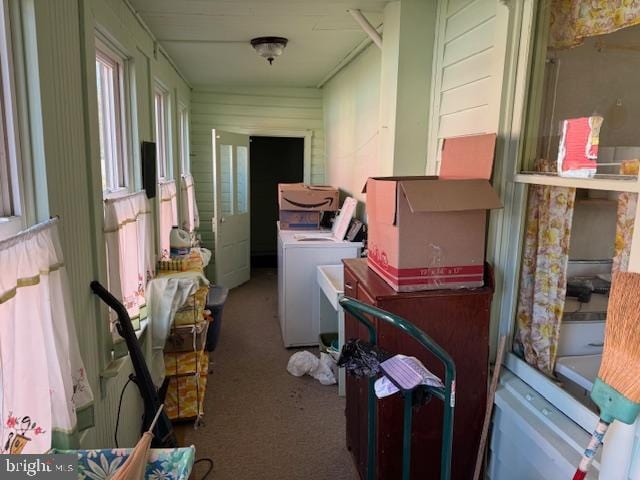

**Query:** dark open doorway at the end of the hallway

left=250, top=137, right=304, bottom=267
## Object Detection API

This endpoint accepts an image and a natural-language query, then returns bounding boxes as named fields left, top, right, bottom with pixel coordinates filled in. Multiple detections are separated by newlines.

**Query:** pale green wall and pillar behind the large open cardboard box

left=323, top=0, right=436, bottom=214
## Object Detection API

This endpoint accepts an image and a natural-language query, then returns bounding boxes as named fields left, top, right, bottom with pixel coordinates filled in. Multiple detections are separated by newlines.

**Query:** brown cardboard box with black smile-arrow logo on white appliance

left=278, top=183, right=340, bottom=212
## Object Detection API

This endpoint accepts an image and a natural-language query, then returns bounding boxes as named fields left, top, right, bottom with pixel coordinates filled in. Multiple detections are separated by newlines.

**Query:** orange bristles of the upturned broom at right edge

left=598, top=272, right=640, bottom=403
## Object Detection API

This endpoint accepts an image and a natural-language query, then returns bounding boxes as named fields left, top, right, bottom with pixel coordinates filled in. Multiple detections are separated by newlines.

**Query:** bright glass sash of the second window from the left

left=96, top=45, right=127, bottom=193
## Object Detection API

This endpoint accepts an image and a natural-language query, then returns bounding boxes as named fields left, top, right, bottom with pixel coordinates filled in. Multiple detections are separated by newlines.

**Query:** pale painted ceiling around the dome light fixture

left=131, top=0, right=389, bottom=87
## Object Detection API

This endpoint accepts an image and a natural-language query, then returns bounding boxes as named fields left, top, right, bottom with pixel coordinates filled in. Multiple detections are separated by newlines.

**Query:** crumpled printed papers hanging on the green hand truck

left=375, top=354, right=444, bottom=398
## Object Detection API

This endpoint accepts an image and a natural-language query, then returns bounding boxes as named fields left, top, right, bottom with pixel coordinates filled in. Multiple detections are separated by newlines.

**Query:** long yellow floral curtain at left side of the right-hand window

left=515, top=164, right=576, bottom=375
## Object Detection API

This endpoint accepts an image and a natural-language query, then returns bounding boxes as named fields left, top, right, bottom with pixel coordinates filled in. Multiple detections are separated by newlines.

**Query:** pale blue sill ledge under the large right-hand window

left=505, top=353, right=598, bottom=432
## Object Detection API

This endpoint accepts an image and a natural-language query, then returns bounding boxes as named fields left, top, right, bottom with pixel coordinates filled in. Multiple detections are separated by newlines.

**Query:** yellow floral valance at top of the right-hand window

left=549, top=0, right=640, bottom=48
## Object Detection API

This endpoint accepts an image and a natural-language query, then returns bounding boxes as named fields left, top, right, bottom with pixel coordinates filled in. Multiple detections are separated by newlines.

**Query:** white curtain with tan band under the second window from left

left=104, top=192, right=155, bottom=337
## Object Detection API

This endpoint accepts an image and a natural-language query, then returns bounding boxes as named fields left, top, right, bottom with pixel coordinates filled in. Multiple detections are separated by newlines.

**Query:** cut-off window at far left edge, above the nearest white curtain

left=0, top=0, right=29, bottom=239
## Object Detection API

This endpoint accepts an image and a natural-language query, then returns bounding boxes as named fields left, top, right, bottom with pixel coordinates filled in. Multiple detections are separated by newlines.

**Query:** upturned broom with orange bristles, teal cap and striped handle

left=573, top=272, right=640, bottom=480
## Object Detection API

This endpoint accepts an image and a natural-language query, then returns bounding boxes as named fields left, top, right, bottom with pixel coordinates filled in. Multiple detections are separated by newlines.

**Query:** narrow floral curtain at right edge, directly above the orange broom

left=612, top=160, right=640, bottom=273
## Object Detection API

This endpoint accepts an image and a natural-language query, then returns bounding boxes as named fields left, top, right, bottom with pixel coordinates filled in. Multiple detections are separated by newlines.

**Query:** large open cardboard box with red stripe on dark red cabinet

left=365, top=177, right=502, bottom=292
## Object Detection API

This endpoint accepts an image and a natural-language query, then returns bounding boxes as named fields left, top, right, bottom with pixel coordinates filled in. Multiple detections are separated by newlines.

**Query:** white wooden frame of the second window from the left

left=95, top=37, right=133, bottom=198
